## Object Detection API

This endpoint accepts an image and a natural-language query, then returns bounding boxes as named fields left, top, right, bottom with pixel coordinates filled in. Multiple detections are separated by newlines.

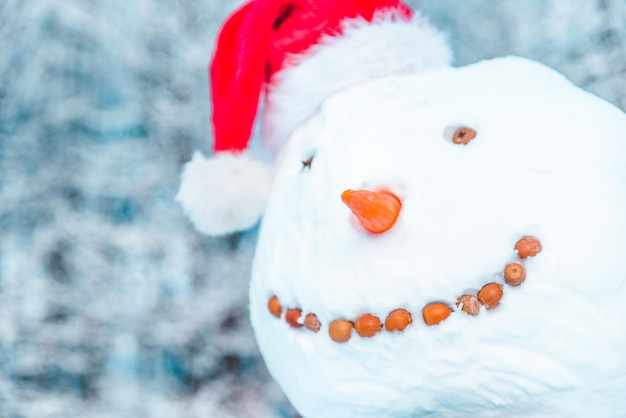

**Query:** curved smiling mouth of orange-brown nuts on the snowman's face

left=267, top=236, right=541, bottom=343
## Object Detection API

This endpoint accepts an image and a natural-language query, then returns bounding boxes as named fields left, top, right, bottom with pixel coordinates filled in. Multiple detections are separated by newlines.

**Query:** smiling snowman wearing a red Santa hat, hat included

left=178, top=0, right=626, bottom=418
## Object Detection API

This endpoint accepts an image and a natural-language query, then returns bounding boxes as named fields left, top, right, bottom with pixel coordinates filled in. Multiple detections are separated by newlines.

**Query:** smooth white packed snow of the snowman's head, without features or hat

left=250, top=57, right=626, bottom=418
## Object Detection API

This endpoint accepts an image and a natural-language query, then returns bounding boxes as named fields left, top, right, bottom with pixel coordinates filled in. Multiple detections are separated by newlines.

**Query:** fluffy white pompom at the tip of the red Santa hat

left=176, top=151, right=272, bottom=236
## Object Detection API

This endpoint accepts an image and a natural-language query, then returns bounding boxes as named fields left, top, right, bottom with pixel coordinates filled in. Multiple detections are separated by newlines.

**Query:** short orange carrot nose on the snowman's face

left=341, top=190, right=402, bottom=234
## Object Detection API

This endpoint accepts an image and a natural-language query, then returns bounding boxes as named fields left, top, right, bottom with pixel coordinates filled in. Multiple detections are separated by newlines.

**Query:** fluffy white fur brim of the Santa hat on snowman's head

left=263, top=12, right=452, bottom=150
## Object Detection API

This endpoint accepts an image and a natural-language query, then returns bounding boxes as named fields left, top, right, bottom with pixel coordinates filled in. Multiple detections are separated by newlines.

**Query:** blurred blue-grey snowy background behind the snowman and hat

left=0, top=0, right=626, bottom=418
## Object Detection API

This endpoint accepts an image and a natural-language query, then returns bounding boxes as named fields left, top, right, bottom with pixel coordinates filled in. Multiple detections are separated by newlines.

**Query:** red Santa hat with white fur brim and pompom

left=176, top=0, right=450, bottom=235
